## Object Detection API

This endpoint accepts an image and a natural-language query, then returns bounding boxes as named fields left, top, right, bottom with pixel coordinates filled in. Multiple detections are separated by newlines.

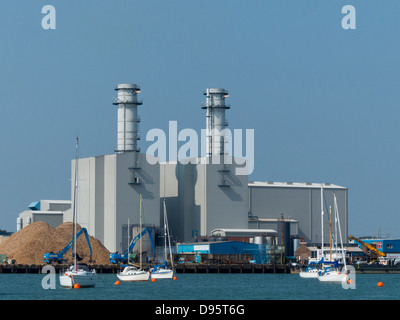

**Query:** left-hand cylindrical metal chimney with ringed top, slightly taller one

left=113, top=84, right=142, bottom=153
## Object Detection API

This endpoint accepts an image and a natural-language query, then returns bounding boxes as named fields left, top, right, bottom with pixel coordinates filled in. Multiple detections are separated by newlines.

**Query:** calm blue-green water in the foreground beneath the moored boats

left=0, top=274, right=400, bottom=300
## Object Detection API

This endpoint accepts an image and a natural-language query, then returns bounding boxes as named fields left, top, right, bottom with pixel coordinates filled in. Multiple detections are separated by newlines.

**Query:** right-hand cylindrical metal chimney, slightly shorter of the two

left=201, top=88, right=230, bottom=157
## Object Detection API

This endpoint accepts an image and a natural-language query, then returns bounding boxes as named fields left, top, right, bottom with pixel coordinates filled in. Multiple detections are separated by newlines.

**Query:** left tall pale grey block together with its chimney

left=71, top=84, right=161, bottom=252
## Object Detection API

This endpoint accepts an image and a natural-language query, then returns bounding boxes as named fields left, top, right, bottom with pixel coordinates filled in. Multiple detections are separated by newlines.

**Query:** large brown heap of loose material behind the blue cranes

left=0, top=221, right=110, bottom=264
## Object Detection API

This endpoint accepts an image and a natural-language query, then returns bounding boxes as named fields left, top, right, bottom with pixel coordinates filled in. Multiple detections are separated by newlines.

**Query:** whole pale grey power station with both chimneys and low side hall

left=18, top=84, right=348, bottom=252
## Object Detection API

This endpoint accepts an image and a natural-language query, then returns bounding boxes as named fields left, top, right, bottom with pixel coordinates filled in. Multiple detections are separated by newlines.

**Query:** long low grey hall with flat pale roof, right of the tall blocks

left=248, top=181, right=348, bottom=243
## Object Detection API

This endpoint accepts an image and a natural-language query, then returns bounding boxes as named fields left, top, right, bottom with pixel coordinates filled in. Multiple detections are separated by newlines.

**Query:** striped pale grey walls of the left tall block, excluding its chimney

left=70, top=152, right=160, bottom=252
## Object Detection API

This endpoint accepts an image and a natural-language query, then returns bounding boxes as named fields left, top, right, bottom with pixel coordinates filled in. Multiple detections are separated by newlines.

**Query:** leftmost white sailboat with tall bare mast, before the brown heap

left=60, top=138, right=97, bottom=288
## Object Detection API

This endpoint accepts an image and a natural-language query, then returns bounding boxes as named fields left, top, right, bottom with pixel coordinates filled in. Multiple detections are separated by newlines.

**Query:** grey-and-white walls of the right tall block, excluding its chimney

left=160, top=159, right=248, bottom=242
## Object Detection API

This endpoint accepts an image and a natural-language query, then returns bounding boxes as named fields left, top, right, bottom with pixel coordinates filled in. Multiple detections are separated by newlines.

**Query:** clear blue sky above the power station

left=0, top=0, right=400, bottom=237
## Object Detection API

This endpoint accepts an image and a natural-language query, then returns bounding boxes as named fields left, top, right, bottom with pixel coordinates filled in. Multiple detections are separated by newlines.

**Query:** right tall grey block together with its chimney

left=160, top=88, right=248, bottom=242
